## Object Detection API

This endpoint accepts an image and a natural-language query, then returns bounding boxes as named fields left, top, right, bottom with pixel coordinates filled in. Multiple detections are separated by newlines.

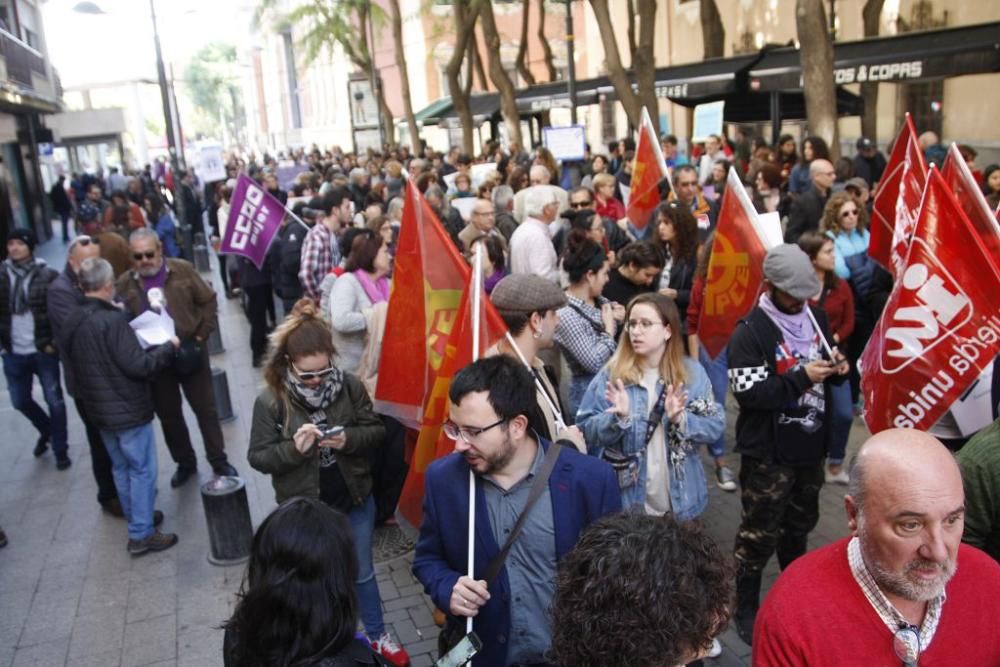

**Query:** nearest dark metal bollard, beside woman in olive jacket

left=201, top=477, right=253, bottom=565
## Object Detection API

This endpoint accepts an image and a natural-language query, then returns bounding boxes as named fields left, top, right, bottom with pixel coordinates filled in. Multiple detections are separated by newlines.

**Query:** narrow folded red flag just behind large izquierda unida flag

left=868, top=113, right=927, bottom=276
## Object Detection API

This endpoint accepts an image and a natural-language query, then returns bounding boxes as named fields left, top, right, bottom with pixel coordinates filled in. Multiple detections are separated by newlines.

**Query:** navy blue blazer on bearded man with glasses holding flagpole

left=413, top=438, right=621, bottom=667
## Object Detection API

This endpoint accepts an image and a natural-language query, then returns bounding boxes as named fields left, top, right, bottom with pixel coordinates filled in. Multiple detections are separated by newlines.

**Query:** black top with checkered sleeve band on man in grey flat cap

left=728, top=306, right=847, bottom=467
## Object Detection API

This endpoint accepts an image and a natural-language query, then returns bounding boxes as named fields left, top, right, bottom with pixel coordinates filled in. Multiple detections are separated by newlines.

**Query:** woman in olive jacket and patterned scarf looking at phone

left=247, top=299, right=409, bottom=667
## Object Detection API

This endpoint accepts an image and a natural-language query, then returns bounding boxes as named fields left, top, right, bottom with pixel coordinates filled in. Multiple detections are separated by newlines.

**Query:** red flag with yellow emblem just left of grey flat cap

left=698, top=168, right=781, bottom=359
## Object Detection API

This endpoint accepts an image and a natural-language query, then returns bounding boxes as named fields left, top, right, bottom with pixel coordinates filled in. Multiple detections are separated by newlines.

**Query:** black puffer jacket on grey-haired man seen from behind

left=59, top=297, right=174, bottom=431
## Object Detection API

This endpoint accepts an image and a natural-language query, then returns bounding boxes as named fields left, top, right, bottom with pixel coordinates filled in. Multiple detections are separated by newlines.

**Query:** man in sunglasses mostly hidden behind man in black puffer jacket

left=48, top=235, right=124, bottom=517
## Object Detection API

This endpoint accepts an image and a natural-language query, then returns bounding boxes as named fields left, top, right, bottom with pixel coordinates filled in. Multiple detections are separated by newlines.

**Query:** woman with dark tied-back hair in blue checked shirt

left=555, top=230, right=625, bottom=415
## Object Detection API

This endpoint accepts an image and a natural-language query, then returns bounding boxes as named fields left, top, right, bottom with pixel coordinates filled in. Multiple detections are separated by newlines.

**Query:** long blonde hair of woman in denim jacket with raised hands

left=608, top=292, right=688, bottom=386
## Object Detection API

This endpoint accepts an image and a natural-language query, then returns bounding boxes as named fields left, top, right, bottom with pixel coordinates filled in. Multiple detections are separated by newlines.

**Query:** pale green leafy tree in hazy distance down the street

left=184, top=43, right=246, bottom=143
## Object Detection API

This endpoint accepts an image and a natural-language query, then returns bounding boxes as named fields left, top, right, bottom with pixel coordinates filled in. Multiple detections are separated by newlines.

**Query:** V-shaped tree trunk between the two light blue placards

left=590, top=0, right=660, bottom=133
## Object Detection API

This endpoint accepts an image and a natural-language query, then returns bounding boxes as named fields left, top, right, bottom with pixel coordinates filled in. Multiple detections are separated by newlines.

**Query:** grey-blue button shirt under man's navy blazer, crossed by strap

left=483, top=445, right=556, bottom=665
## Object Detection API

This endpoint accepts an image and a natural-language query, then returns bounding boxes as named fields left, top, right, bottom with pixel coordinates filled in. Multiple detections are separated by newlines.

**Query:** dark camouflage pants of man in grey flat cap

left=735, top=456, right=823, bottom=574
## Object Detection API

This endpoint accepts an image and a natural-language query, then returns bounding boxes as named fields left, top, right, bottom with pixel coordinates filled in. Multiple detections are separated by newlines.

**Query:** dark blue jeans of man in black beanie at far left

left=3, top=352, right=67, bottom=457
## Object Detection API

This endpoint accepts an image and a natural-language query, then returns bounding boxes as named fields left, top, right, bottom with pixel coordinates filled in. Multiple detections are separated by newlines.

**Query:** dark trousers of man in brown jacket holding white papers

left=153, top=348, right=226, bottom=468
